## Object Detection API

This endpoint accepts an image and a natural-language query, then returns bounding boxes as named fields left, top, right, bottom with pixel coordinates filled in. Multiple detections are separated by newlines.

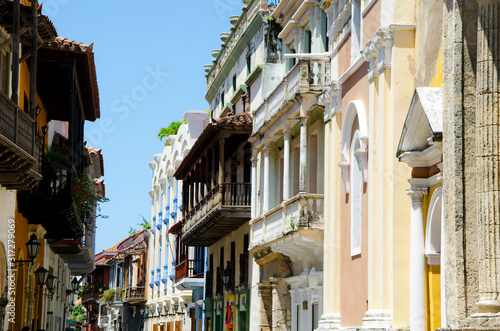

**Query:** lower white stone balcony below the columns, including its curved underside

left=250, top=193, right=324, bottom=261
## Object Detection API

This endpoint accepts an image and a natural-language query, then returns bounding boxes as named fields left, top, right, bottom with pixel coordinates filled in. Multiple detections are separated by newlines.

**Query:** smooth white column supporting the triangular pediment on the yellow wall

left=406, top=186, right=427, bottom=331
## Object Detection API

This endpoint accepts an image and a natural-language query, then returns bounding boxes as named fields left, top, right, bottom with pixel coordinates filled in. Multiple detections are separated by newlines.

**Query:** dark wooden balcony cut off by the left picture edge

left=0, top=92, right=42, bottom=190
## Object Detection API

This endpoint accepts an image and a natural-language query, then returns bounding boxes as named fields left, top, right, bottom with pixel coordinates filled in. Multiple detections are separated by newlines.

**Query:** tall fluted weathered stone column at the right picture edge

left=476, top=0, right=500, bottom=313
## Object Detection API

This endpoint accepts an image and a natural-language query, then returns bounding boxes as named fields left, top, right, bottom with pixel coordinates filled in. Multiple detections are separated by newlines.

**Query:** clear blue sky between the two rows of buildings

left=47, top=0, right=239, bottom=252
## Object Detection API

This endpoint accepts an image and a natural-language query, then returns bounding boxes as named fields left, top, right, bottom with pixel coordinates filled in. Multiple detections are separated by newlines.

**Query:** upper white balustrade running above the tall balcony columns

left=253, top=59, right=330, bottom=133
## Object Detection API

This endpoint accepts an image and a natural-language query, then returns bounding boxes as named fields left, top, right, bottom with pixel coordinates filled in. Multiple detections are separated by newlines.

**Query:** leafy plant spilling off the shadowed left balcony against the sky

left=71, top=175, right=109, bottom=236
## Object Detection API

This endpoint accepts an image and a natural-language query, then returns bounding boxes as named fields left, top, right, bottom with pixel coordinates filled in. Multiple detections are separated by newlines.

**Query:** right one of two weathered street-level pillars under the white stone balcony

left=270, top=278, right=291, bottom=331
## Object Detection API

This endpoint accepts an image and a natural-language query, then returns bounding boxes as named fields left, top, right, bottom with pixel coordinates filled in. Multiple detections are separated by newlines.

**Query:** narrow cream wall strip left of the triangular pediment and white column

left=386, top=29, right=415, bottom=327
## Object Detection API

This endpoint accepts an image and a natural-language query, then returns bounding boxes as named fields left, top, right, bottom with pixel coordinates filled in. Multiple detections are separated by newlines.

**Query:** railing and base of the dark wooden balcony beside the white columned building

left=182, top=183, right=251, bottom=246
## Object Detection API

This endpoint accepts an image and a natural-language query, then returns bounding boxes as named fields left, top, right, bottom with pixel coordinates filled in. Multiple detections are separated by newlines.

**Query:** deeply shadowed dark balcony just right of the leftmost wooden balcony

left=17, top=162, right=83, bottom=239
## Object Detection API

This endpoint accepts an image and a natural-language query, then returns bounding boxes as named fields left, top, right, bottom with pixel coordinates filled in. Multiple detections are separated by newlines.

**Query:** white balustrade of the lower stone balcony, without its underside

left=250, top=193, right=324, bottom=247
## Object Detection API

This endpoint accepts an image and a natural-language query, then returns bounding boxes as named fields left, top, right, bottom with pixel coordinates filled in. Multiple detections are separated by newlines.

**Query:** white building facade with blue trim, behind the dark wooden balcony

left=147, top=111, right=210, bottom=330
